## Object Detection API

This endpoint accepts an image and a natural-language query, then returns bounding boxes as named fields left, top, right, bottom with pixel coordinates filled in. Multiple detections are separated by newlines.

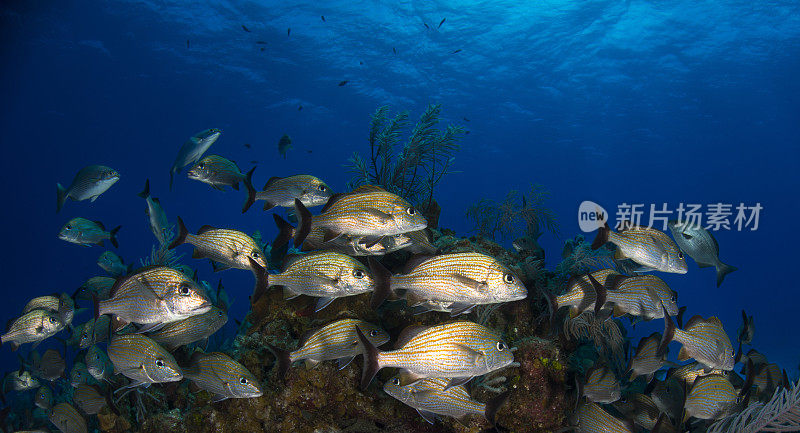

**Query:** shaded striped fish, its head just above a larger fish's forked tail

left=270, top=319, right=389, bottom=377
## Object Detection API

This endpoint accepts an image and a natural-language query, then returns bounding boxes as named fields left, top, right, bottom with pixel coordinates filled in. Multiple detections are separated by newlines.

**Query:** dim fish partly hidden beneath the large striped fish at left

left=147, top=306, right=228, bottom=351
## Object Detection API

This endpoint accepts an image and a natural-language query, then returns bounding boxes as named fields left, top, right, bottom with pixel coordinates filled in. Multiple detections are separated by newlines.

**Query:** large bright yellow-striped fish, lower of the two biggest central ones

left=356, top=321, right=514, bottom=389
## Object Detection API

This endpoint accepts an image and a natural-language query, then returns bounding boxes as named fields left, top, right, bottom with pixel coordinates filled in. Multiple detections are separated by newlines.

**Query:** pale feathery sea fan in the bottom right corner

left=708, top=380, right=800, bottom=433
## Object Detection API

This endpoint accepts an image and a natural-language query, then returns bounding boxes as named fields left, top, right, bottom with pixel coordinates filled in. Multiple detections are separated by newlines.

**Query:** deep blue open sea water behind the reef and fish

left=0, top=0, right=800, bottom=426
